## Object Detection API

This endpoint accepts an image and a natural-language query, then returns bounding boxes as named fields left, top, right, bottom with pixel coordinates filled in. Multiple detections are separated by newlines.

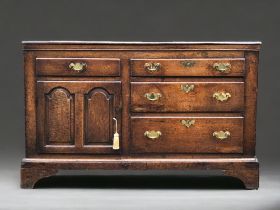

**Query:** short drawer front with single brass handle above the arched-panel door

left=36, top=58, right=120, bottom=76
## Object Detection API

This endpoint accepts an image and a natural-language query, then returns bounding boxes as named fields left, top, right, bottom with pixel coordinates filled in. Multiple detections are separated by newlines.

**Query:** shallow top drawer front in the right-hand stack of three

left=131, top=58, right=245, bottom=77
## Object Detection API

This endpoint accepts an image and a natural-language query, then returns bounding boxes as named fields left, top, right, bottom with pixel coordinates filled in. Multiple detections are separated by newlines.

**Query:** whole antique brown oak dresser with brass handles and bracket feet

left=21, top=41, right=260, bottom=189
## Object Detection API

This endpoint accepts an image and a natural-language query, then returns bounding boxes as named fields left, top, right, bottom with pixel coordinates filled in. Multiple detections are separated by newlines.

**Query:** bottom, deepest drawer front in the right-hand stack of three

left=131, top=117, right=243, bottom=153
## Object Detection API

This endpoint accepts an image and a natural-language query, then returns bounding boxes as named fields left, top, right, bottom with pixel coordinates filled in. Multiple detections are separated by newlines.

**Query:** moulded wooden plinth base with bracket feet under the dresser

left=21, top=158, right=259, bottom=189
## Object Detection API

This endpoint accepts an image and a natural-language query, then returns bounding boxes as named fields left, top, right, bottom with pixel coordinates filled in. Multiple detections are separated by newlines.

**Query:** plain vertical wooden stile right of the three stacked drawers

left=244, top=51, right=259, bottom=156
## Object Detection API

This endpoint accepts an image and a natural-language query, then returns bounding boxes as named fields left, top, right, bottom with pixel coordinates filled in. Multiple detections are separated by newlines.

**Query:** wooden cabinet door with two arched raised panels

left=37, top=81, right=121, bottom=154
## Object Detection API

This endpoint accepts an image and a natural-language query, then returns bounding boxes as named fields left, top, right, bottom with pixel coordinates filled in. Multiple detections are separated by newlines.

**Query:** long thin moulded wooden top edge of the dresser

left=22, top=41, right=261, bottom=50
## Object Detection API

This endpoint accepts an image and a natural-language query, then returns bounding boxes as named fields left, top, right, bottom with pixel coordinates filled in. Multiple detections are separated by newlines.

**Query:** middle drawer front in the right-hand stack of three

left=131, top=82, right=244, bottom=112
